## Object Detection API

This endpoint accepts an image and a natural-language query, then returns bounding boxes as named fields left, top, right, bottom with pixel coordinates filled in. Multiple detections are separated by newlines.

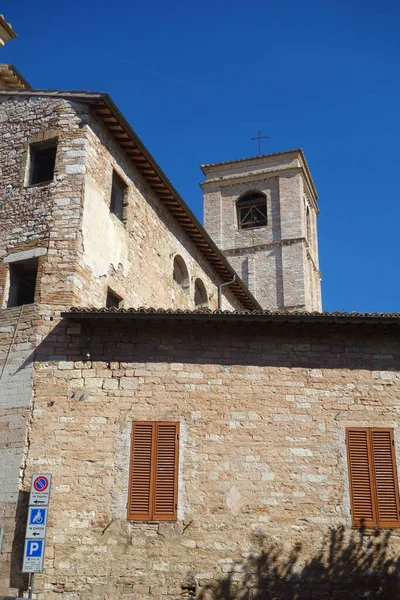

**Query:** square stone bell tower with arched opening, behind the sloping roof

left=201, top=149, right=321, bottom=311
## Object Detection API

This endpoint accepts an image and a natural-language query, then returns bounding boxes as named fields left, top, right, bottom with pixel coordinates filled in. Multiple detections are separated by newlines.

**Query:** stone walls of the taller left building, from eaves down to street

left=0, top=91, right=251, bottom=594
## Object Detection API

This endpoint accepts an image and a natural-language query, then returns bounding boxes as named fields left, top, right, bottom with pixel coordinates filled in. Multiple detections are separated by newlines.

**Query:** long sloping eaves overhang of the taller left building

left=0, top=90, right=261, bottom=310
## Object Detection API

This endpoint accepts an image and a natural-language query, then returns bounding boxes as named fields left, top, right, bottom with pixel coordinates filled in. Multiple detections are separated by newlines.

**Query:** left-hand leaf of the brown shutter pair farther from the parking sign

left=346, top=428, right=377, bottom=527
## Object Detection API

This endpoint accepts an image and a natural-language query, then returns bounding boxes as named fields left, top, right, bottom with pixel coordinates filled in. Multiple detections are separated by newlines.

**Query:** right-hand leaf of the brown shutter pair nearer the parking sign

left=154, top=423, right=179, bottom=521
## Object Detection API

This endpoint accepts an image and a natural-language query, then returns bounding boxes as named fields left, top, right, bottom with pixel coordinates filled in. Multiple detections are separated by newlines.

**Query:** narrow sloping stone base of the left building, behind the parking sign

left=0, top=306, right=38, bottom=595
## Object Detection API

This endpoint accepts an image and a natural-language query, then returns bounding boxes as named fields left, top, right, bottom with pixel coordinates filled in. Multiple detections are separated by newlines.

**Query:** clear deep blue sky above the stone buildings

left=0, top=0, right=400, bottom=312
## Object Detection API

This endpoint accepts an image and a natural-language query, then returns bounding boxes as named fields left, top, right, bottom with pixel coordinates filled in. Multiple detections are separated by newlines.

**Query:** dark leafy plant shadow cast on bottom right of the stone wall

left=197, top=528, right=400, bottom=600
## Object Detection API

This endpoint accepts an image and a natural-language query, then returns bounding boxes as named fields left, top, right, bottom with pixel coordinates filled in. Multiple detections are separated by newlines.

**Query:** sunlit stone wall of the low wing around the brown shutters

left=24, top=320, right=400, bottom=600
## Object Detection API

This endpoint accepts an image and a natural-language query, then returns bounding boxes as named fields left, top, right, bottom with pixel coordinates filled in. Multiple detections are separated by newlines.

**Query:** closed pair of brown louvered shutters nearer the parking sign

left=128, top=421, right=179, bottom=521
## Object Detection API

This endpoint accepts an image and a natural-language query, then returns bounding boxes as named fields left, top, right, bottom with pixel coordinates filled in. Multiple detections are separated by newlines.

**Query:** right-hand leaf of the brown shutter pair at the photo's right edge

left=370, top=429, right=400, bottom=527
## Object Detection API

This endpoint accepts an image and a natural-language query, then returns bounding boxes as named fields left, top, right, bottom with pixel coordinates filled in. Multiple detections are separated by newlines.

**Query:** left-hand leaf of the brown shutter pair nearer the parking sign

left=128, top=423, right=155, bottom=521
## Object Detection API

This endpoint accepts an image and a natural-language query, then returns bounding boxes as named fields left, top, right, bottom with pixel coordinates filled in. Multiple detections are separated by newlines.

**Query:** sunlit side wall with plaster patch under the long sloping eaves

left=79, top=110, right=244, bottom=309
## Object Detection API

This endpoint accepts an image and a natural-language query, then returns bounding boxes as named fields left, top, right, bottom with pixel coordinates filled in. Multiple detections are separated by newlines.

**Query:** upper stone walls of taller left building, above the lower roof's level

left=0, top=96, right=241, bottom=316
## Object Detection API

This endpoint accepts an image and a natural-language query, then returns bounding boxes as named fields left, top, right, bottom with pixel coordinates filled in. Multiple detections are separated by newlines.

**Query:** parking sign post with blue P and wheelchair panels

left=22, top=473, right=51, bottom=598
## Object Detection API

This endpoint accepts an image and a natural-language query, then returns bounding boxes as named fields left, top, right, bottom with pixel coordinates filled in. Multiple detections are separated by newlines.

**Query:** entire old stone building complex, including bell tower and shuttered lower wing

left=0, top=36, right=400, bottom=600
